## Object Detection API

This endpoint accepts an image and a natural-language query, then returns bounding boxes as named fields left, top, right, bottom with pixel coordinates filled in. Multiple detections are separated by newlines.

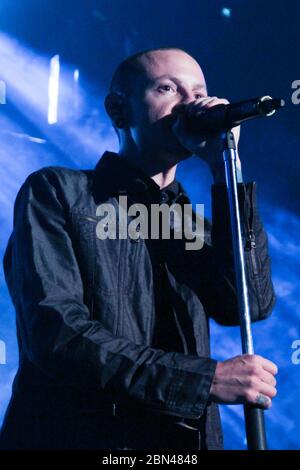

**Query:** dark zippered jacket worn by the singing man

left=0, top=152, right=274, bottom=450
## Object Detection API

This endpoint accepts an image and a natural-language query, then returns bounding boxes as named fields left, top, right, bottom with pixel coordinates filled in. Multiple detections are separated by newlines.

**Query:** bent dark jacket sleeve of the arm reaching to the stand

left=4, top=168, right=216, bottom=418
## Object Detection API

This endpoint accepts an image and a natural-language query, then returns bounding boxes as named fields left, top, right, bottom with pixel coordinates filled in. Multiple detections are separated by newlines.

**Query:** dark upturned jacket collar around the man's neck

left=93, top=152, right=187, bottom=204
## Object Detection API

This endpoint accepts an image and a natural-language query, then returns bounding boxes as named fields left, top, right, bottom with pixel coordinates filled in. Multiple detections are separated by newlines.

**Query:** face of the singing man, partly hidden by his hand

left=125, top=50, right=207, bottom=162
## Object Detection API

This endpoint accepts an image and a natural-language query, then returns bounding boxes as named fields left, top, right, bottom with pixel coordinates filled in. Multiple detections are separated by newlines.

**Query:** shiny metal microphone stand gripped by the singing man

left=222, top=130, right=267, bottom=450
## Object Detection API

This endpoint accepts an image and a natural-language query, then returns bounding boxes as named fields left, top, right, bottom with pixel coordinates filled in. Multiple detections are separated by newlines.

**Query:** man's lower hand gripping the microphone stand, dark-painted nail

left=210, top=354, right=278, bottom=408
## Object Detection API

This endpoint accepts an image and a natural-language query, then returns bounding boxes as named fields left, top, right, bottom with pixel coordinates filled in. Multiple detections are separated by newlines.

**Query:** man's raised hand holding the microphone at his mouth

left=172, top=96, right=241, bottom=181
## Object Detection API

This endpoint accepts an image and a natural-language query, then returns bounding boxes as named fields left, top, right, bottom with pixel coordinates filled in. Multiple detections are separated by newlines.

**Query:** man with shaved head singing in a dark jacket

left=0, top=48, right=277, bottom=451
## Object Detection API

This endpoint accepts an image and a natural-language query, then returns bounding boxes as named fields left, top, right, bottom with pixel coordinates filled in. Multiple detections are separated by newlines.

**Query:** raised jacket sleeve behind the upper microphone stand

left=200, top=182, right=275, bottom=326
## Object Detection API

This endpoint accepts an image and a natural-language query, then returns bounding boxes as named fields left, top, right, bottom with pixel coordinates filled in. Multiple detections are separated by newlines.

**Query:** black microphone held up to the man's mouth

left=187, top=96, right=285, bottom=133
